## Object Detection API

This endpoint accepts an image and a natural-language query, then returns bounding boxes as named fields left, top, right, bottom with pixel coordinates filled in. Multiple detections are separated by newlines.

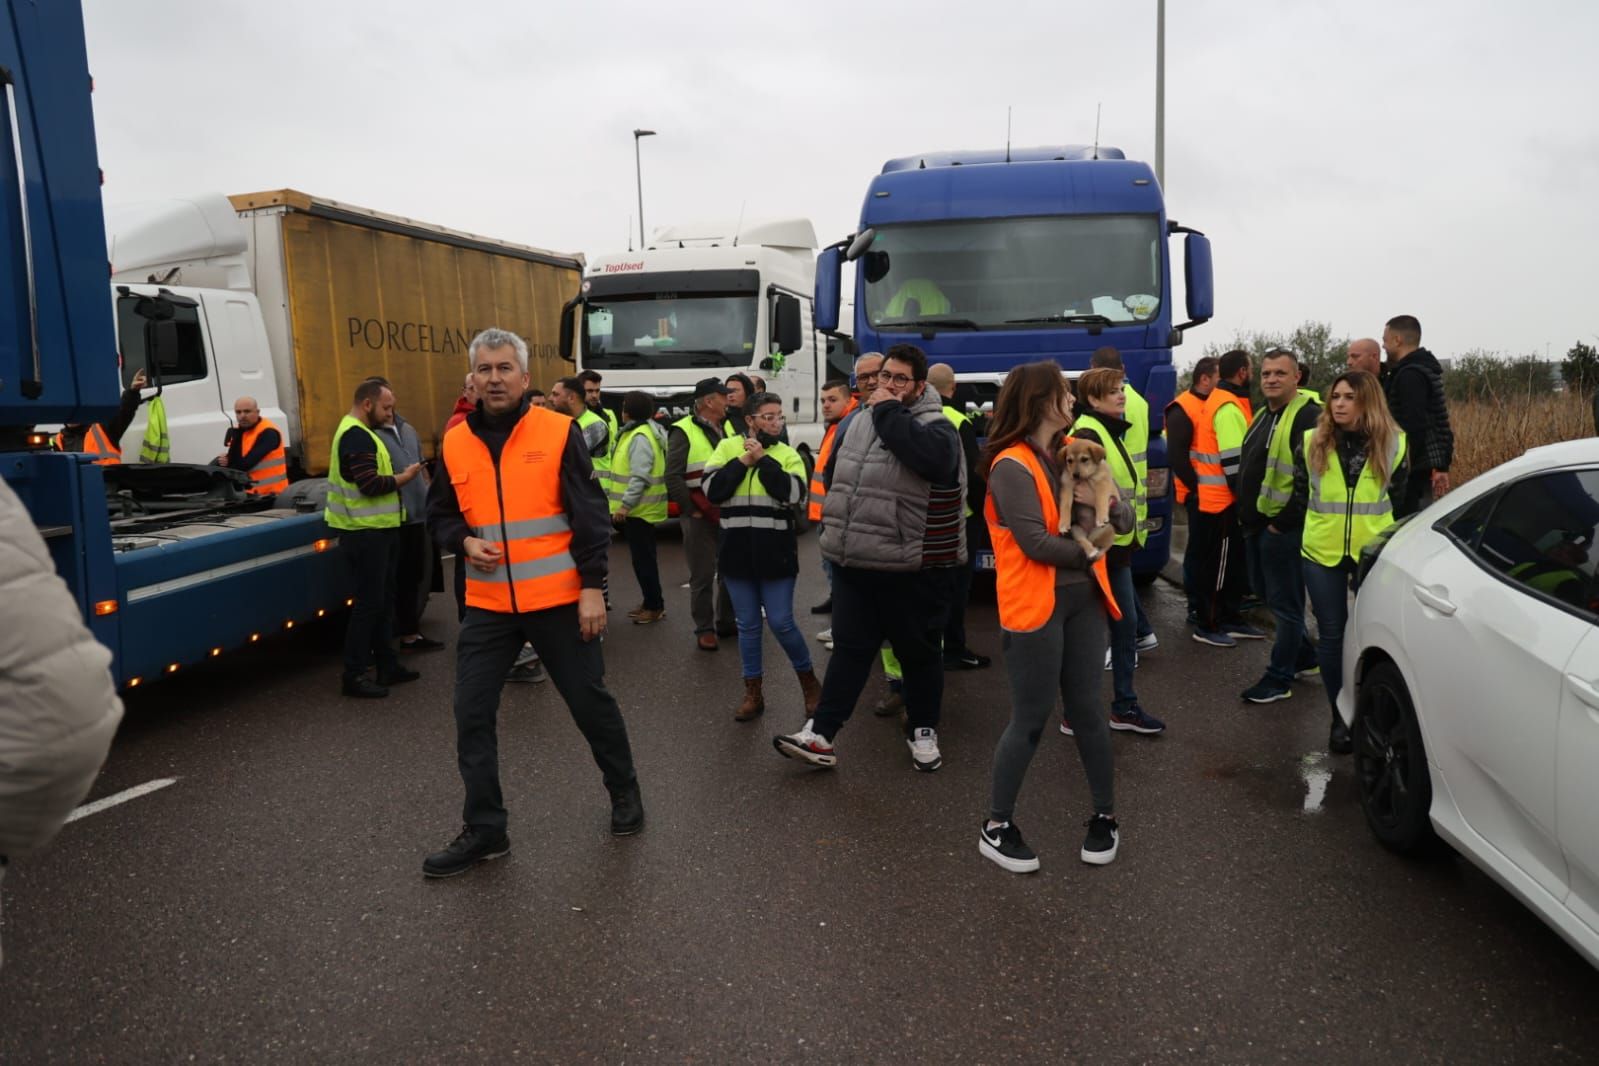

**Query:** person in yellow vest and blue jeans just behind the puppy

left=1060, top=366, right=1166, bottom=735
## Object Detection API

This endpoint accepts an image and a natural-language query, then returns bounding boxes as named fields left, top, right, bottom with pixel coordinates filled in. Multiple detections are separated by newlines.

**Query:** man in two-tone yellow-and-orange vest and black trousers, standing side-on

left=1186, top=348, right=1266, bottom=647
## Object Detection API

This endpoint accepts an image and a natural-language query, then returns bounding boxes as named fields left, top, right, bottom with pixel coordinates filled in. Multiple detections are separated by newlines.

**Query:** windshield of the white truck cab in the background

left=584, top=292, right=756, bottom=371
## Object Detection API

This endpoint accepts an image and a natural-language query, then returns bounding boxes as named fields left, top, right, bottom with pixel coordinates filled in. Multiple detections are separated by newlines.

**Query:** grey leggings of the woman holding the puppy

left=988, top=582, right=1116, bottom=821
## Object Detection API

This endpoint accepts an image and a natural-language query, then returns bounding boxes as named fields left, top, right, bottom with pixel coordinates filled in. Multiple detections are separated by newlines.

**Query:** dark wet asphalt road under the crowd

left=0, top=537, right=1599, bottom=1064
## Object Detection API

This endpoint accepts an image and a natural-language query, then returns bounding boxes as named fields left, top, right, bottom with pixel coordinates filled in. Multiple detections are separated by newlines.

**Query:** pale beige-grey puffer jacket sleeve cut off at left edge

left=0, top=481, right=122, bottom=858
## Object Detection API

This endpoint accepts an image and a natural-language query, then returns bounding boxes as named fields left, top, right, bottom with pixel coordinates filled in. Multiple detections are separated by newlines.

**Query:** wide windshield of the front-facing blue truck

left=859, top=214, right=1162, bottom=329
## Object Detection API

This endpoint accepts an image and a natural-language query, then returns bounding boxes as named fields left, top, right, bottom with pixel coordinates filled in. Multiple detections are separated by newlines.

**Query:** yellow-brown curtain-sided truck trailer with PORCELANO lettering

left=230, top=189, right=584, bottom=475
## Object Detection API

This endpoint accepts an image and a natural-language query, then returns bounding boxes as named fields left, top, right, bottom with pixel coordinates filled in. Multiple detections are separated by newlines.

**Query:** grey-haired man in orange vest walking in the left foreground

left=422, top=329, right=644, bottom=877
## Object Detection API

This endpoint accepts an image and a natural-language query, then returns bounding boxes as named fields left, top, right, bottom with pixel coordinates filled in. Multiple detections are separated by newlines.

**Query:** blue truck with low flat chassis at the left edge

left=0, top=0, right=349, bottom=687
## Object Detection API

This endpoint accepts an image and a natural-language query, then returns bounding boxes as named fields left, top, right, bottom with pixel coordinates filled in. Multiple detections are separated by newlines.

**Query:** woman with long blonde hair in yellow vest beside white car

left=1294, top=371, right=1406, bottom=754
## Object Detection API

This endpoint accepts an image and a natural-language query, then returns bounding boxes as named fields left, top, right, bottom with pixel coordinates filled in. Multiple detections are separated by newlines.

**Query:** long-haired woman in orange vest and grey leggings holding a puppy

left=977, top=363, right=1134, bottom=873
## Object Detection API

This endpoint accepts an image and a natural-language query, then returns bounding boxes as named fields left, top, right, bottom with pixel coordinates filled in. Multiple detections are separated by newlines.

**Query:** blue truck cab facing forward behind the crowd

left=815, top=145, right=1214, bottom=577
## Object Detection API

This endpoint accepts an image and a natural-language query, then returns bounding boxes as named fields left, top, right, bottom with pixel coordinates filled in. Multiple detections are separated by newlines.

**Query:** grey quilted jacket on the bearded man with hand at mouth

left=822, top=381, right=966, bottom=572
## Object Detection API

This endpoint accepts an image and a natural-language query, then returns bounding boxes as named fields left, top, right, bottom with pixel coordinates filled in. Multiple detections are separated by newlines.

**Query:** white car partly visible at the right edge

left=1338, top=438, right=1599, bottom=965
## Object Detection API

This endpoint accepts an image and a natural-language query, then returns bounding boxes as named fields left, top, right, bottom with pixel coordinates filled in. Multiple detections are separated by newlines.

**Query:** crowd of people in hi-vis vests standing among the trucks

left=40, top=316, right=1452, bottom=876
